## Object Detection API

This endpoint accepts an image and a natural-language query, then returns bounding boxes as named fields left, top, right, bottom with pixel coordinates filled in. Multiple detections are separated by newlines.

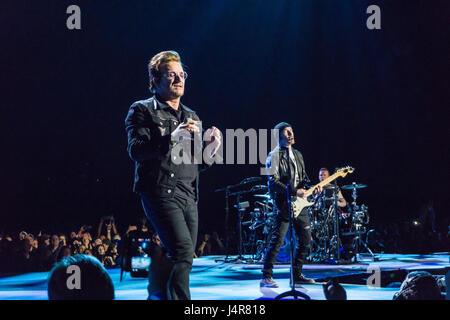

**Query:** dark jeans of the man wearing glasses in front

left=141, top=194, right=198, bottom=300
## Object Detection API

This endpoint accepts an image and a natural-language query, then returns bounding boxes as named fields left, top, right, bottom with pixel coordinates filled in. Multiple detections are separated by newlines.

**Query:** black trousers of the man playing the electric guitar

left=262, top=208, right=311, bottom=277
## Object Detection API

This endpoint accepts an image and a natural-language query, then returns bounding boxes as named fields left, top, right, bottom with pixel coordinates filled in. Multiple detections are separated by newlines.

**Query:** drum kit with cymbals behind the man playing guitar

left=216, top=178, right=374, bottom=263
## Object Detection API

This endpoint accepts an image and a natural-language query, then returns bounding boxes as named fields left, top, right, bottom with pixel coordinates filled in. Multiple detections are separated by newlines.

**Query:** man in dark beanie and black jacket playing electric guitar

left=260, top=122, right=322, bottom=288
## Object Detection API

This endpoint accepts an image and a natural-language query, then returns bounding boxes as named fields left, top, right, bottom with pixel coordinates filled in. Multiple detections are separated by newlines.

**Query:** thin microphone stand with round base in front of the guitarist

left=275, top=149, right=311, bottom=300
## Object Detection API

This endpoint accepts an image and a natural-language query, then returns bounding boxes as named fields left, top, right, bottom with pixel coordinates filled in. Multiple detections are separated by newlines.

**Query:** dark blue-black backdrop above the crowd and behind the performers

left=0, top=0, right=450, bottom=240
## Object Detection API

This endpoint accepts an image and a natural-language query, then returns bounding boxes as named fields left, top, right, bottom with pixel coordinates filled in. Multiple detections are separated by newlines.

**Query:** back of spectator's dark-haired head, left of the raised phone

left=47, top=254, right=114, bottom=300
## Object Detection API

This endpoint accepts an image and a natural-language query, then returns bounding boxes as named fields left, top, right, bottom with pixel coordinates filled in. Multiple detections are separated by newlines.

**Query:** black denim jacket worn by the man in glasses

left=125, top=97, right=207, bottom=200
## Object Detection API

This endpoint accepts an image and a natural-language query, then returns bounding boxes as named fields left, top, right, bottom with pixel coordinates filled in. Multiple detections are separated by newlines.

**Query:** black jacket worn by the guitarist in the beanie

left=266, top=146, right=308, bottom=219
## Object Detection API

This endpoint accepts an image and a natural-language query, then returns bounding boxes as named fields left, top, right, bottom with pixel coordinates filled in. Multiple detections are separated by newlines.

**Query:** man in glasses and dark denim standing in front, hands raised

left=125, top=51, right=221, bottom=300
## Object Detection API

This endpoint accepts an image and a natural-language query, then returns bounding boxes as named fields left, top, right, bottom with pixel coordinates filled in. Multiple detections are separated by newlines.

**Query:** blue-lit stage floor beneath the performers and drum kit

left=0, top=252, right=450, bottom=300
